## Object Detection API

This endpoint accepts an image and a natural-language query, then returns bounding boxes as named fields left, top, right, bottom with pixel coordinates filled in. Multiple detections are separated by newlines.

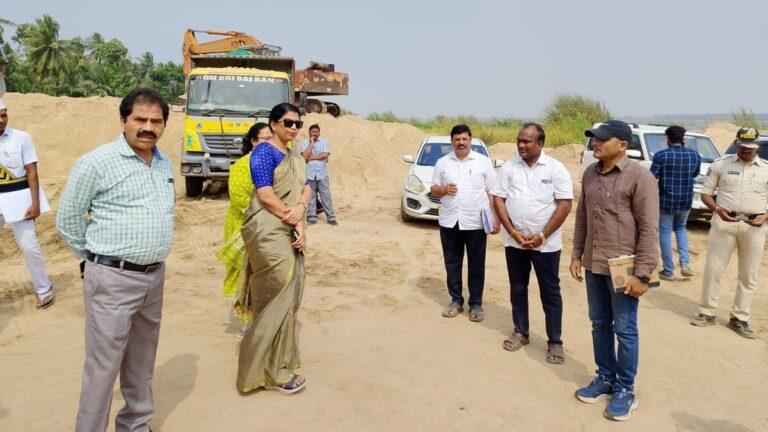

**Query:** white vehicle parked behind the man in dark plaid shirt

left=581, top=123, right=720, bottom=219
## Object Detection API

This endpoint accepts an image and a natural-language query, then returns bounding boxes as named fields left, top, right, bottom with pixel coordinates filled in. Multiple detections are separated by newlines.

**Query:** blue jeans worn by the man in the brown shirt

left=586, top=271, right=640, bottom=391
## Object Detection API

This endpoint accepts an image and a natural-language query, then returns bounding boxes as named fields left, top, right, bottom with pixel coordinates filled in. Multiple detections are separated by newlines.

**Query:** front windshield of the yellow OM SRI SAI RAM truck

left=187, top=75, right=288, bottom=116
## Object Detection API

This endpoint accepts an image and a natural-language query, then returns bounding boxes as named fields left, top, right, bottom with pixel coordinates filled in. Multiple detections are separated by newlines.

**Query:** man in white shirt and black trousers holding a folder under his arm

left=430, top=125, right=500, bottom=322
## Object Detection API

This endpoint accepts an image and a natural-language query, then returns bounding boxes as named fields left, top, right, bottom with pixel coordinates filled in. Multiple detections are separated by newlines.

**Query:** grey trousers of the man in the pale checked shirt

left=75, top=261, right=165, bottom=432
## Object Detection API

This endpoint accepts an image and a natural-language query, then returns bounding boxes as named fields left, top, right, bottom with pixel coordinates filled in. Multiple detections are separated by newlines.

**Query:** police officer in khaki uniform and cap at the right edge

left=691, top=128, right=768, bottom=339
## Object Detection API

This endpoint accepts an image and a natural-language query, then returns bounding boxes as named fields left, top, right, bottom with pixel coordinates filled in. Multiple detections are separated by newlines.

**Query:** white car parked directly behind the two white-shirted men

left=400, top=136, right=504, bottom=222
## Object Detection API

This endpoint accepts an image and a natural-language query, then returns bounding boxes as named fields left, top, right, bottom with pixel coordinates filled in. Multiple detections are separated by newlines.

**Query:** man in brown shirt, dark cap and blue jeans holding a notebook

left=570, top=120, right=659, bottom=421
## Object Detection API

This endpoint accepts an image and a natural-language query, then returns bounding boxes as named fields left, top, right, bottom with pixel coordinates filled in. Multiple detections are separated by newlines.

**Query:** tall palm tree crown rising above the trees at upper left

left=22, top=15, right=68, bottom=79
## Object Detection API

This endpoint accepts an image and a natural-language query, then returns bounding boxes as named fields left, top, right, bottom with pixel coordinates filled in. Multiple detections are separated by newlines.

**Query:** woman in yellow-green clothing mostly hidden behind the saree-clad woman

left=217, top=123, right=272, bottom=336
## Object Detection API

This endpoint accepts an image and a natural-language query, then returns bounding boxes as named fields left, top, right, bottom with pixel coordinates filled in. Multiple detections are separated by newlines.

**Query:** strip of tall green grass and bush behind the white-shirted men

left=367, top=94, right=611, bottom=147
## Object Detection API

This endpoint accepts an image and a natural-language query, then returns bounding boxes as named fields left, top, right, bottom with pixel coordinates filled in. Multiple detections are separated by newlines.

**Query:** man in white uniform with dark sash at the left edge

left=0, top=100, right=54, bottom=309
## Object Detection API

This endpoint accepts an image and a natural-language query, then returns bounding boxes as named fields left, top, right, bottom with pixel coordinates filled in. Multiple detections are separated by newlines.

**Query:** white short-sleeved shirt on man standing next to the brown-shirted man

left=491, top=153, right=573, bottom=252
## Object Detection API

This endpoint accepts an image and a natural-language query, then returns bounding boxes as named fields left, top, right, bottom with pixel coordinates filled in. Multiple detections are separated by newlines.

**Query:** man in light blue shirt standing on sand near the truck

left=301, top=124, right=339, bottom=225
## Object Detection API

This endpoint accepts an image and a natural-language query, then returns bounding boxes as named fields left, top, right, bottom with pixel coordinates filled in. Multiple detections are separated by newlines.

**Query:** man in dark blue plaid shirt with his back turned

left=651, top=126, right=701, bottom=281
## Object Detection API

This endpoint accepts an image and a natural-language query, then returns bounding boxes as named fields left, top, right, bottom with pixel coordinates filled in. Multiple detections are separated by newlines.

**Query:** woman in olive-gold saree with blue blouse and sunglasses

left=237, top=103, right=310, bottom=394
